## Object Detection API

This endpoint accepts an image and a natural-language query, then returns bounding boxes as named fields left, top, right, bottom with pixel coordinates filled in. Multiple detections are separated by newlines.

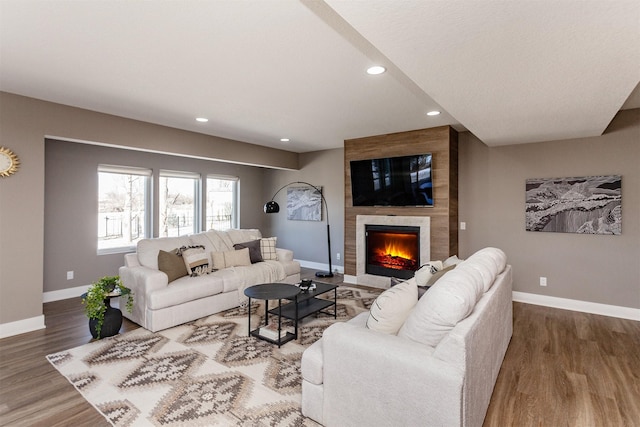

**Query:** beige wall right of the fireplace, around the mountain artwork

left=459, top=109, right=640, bottom=308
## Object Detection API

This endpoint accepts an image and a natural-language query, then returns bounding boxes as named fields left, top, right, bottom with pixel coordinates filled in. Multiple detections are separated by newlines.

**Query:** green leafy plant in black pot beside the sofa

left=82, top=276, right=133, bottom=339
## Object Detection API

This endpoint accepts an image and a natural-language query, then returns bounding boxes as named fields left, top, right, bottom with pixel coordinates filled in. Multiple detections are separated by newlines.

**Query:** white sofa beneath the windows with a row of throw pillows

left=119, top=229, right=300, bottom=332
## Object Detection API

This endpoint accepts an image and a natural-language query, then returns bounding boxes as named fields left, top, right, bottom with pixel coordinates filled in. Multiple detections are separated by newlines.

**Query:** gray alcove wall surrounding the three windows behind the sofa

left=44, top=140, right=264, bottom=292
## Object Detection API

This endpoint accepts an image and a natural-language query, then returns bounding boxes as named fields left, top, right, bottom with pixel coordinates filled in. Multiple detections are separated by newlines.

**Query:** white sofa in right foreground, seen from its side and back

left=301, top=248, right=513, bottom=427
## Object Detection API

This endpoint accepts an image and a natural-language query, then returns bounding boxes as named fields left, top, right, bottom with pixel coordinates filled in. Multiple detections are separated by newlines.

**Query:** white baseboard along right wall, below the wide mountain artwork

left=513, top=291, right=640, bottom=320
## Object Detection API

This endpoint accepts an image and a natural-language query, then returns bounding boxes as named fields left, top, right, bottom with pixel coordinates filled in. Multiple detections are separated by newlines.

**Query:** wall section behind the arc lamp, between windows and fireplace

left=263, top=148, right=344, bottom=272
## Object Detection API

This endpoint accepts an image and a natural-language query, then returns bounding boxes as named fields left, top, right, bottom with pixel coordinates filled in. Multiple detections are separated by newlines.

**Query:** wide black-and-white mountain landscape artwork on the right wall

left=525, top=175, right=622, bottom=235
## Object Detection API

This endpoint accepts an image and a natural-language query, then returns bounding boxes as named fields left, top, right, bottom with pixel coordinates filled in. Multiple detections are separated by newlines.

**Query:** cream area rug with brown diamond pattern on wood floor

left=47, top=286, right=377, bottom=426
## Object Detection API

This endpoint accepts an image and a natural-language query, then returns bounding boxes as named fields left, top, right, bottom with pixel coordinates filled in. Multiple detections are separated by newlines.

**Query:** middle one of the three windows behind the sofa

left=158, top=171, right=200, bottom=237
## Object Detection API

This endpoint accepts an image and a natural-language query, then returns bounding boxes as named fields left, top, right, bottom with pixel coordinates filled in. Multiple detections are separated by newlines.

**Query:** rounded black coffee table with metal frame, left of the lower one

left=244, top=283, right=300, bottom=347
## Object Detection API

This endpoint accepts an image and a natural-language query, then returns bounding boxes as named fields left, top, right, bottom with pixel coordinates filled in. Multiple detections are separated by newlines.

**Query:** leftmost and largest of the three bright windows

left=98, top=165, right=151, bottom=254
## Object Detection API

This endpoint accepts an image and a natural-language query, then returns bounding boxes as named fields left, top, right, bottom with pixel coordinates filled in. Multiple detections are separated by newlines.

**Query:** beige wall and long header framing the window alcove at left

left=0, top=92, right=298, bottom=326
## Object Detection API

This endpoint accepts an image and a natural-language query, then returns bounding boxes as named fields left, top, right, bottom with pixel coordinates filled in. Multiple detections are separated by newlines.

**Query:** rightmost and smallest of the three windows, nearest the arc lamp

left=204, top=175, right=238, bottom=230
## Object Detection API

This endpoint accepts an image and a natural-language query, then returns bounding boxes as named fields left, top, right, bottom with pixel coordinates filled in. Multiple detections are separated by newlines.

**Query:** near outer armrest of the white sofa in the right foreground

left=322, top=323, right=464, bottom=426
